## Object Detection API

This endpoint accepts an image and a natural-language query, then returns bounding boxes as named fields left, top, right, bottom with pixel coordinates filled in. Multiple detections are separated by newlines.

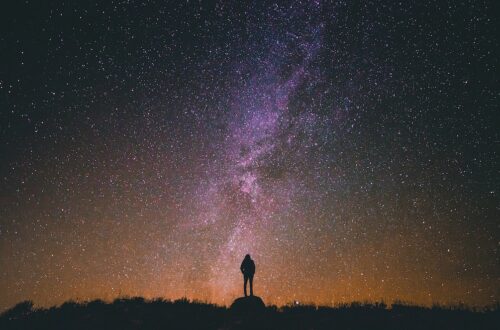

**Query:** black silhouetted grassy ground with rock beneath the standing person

left=0, top=297, right=500, bottom=330
